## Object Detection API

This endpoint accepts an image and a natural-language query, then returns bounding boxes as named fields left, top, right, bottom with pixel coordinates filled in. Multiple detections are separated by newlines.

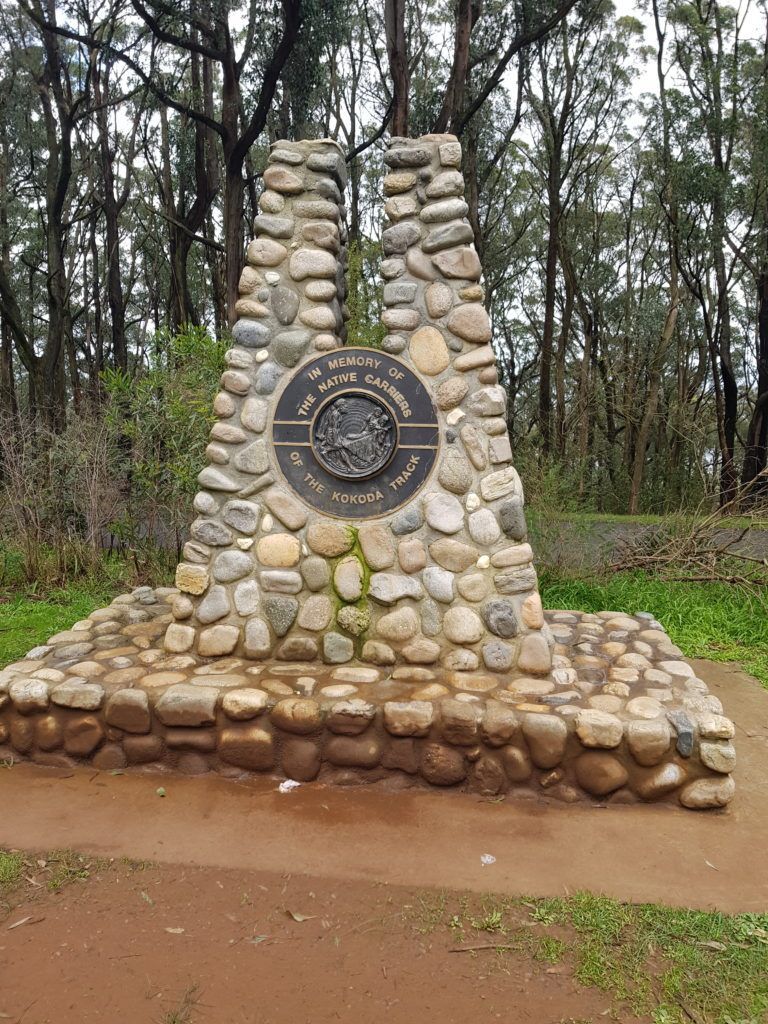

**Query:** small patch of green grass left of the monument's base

left=0, top=584, right=116, bottom=665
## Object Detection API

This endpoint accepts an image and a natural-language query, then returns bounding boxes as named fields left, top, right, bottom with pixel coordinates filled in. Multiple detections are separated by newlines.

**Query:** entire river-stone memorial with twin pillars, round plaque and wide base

left=0, top=135, right=734, bottom=808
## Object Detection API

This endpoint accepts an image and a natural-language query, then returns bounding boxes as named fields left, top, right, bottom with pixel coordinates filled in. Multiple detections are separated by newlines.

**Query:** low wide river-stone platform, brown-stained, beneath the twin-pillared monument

left=0, top=588, right=735, bottom=809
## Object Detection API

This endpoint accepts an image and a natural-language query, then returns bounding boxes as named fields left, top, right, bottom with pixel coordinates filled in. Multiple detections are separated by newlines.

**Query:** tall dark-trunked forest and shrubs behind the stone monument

left=0, top=0, right=768, bottom=579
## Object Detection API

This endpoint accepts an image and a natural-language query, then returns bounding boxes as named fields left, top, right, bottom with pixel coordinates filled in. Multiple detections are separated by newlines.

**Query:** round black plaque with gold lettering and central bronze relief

left=272, top=348, right=438, bottom=519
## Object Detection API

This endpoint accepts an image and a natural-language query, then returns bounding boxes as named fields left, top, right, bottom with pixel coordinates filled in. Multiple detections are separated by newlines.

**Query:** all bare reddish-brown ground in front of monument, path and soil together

left=0, top=663, right=768, bottom=1024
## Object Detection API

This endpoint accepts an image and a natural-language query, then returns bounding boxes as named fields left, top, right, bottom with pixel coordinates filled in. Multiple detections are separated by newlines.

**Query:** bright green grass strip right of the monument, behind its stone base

left=541, top=572, right=768, bottom=687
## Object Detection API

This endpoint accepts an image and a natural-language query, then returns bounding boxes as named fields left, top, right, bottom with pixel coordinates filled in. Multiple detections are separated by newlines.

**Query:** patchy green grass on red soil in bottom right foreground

left=410, top=893, right=768, bottom=1024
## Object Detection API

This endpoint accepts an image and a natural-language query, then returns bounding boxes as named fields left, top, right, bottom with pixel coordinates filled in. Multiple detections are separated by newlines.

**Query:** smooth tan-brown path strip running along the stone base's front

left=0, top=663, right=768, bottom=911
